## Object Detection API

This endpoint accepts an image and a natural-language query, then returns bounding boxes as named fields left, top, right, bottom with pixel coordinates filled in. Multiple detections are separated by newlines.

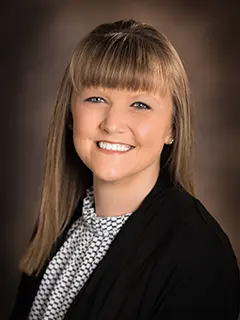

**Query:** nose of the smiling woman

left=100, top=106, right=128, bottom=134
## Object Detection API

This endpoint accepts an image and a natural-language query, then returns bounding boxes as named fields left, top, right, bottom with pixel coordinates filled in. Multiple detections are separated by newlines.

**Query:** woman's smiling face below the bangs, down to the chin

left=71, top=87, right=172, bottom=182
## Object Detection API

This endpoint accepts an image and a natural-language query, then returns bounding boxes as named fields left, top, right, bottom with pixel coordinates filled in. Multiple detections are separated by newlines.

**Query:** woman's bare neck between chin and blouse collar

left=93, top=169, right=159, bottom=217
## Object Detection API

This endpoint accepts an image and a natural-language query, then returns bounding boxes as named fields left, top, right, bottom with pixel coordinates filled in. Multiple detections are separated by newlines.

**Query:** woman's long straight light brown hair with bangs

left=21, top=20, right=194, bottom=274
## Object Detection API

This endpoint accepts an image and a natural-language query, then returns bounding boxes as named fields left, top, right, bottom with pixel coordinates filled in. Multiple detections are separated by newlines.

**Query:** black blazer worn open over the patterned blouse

left=10, top=174, right=240, bottom=320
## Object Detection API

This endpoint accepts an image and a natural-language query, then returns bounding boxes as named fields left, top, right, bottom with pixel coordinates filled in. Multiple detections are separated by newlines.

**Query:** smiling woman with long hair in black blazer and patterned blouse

left=11, top=20, right=240, bottom=320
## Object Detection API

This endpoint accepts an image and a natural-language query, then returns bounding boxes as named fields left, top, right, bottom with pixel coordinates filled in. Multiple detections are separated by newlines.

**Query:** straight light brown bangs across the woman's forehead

left=70, top=33, right=171, bottom=94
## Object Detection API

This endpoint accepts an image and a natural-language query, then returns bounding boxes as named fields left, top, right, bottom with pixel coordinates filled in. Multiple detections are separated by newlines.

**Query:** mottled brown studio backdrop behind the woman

left=0, top=0, right=240, bottom=319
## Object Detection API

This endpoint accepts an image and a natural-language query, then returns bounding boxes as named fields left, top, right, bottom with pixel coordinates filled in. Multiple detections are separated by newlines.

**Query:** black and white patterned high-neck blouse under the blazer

left=28, top=188, right=131, bottom=320
